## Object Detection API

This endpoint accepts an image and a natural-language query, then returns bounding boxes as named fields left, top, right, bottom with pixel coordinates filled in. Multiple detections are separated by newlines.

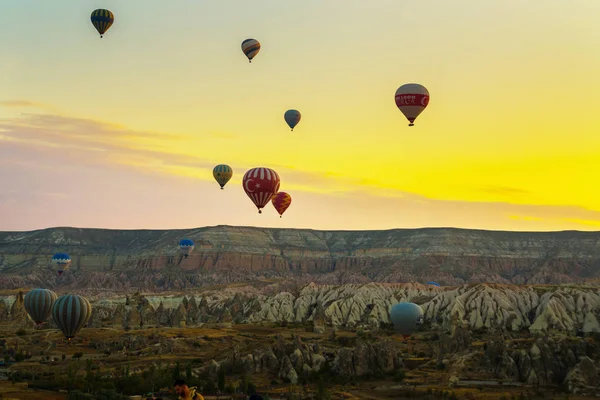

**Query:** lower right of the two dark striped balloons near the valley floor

left=52, top=294, right=92, bottom=341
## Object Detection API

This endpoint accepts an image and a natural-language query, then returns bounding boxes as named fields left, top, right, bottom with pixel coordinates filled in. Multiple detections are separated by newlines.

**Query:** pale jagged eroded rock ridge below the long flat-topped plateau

left=0, top=283, right=600, bottom=335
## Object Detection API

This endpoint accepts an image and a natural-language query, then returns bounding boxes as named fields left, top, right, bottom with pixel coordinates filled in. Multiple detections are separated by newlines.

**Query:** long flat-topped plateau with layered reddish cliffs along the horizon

left=0, top=226, right=600, bottom=292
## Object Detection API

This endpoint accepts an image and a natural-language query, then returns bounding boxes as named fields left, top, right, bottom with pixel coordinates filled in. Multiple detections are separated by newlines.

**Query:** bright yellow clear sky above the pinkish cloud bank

left=0, top=0, right=600, bottom=229
